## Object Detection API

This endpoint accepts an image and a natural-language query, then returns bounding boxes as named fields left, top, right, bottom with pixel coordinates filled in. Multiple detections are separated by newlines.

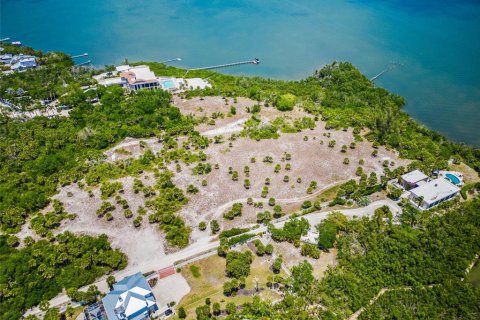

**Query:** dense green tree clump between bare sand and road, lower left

left=0, top=232, right=127, bottom=320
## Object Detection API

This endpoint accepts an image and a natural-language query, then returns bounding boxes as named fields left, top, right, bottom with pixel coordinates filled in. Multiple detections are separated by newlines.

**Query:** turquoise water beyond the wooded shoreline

left=0, top=0, right=480, bottom=146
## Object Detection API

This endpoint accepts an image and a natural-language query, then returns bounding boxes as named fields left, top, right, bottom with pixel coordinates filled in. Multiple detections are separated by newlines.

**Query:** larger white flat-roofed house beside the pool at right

left=409, top=178, right=460, bottom=210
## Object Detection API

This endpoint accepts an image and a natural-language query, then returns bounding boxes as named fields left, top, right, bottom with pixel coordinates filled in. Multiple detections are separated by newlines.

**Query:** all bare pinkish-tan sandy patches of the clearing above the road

left=20, top=97, right=408, bottom=272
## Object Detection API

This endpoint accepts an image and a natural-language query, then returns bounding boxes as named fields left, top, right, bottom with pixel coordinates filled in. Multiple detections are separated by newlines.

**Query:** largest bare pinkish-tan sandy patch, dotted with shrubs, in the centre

left=172, top=125, right=407, bottom=237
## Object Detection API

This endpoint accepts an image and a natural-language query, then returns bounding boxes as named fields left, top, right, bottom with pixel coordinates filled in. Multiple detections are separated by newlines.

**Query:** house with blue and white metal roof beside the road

left=102, top=272, right=158, bottom=320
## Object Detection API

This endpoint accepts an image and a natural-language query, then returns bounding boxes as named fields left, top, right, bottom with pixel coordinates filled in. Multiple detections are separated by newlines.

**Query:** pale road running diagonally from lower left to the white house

left=25, top=195, right=401, bottom=315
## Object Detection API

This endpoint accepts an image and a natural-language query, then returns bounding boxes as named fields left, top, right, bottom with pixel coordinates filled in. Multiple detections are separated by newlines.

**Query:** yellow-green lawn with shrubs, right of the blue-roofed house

left=179, top=246, right=279, bottom=319
